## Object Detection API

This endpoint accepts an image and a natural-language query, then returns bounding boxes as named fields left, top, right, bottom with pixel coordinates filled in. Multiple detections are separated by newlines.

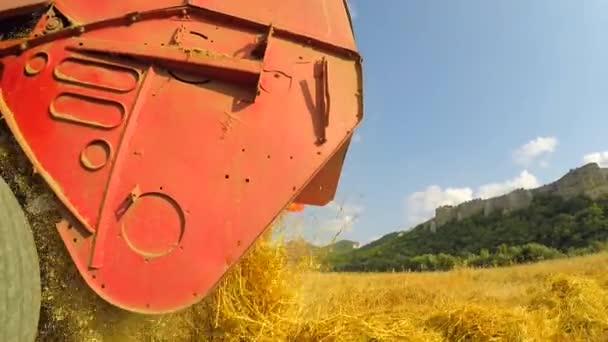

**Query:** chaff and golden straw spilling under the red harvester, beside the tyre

left=0, top=121, right=300, bottom=342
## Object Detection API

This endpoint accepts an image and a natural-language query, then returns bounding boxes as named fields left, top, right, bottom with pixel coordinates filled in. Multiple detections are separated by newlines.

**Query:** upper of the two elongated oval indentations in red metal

left=54, top=57, right=139, bottom=92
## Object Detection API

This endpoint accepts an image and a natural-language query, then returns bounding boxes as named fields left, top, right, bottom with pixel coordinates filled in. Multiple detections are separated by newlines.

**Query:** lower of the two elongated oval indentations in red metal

left=49, top=93, right=126, bottom=129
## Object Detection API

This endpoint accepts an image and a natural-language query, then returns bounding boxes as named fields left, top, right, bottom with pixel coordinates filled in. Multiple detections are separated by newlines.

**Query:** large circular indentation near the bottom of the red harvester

left=122, top=192, right=186, bottom=259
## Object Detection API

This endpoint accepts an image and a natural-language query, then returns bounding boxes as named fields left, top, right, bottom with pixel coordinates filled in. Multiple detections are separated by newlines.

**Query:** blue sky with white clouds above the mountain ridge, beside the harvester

left=286, top=0, right=608, bottom=243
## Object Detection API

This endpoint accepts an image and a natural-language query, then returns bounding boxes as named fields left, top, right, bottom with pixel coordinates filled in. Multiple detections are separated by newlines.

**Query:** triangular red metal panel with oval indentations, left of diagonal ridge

left=1, top=42, right=141, bottom=231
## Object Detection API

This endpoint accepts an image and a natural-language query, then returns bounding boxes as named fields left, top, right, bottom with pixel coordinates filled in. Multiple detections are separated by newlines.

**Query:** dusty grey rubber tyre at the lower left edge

left=0, top=177, right=40, bottom=342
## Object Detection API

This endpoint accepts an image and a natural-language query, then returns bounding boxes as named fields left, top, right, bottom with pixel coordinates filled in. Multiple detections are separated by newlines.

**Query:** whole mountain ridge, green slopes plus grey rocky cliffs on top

left=325, top=163, right=608, bottom=271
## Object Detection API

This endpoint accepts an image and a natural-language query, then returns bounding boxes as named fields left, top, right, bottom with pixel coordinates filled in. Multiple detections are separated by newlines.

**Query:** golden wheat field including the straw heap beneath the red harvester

left=47, top=231, right=608, bottom=341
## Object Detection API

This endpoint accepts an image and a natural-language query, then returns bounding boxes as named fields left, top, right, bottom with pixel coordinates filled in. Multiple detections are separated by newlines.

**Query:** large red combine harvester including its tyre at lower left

left=0, top=0, right=362, bottom=341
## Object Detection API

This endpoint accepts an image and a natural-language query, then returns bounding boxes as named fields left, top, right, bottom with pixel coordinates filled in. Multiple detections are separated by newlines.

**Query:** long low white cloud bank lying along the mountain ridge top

left=405, top=170, right=540, bottom=226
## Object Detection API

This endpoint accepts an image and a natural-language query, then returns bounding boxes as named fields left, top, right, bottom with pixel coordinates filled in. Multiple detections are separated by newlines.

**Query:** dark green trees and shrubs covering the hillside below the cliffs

left=324, top=195, right=608, bottom=271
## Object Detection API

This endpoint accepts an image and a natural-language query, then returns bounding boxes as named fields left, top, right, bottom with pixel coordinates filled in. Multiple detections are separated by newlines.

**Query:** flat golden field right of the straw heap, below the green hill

left=302, top=253, right=608, bottom=341
